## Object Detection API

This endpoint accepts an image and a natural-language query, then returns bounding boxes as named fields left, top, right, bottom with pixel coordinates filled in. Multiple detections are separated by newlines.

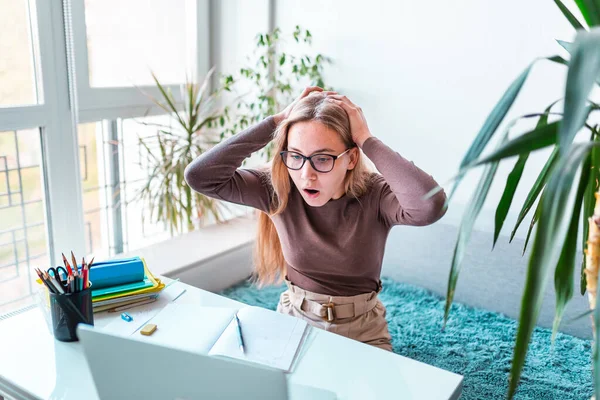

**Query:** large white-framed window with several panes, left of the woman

left=0, top=0, right=208, bottom=314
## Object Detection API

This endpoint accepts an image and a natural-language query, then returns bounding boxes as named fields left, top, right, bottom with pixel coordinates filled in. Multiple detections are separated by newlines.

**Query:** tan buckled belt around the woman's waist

left=288, top=290, right=378, bottom=322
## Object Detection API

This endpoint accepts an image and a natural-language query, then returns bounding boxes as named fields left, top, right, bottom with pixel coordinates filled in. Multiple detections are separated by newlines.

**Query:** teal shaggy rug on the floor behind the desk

left=221, top=279, right=593, bottom=400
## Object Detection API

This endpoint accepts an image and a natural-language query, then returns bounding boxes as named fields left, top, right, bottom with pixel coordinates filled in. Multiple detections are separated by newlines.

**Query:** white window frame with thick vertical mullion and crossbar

left=0, top=0, right=210, bottom=265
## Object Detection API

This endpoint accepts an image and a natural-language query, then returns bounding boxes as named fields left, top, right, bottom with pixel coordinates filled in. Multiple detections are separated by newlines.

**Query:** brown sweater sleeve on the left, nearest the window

left=185, top=117, right=276, bottom=212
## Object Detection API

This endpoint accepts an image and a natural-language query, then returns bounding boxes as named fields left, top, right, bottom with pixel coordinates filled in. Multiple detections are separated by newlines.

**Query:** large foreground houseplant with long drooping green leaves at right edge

left=438, top=0, right=600, bottom=398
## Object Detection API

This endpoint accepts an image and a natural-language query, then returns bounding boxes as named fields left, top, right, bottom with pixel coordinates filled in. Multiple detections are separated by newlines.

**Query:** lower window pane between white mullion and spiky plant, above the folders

left=78, top=117, right=171, bottom=258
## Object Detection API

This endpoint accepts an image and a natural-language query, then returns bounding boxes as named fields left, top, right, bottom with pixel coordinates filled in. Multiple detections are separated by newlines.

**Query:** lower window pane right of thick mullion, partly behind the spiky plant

left=78, top=116, right=253, bottom=259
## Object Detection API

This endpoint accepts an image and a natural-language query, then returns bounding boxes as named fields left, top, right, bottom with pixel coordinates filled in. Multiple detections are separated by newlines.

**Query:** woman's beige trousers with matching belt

left=277, top=280, right=392, bottom=351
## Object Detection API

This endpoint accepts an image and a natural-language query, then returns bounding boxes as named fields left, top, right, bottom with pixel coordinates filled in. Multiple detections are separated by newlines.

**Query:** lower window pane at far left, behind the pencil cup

left=0, top=129, right=49, bottom=314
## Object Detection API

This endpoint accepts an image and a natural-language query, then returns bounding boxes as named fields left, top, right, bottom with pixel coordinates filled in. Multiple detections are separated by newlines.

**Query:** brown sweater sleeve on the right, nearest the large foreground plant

left=362, top=137, right=446, bottom=226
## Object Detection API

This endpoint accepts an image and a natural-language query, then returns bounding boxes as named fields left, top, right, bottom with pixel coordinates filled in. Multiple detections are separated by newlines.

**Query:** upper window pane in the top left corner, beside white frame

left=0, top=0, right=37, bottom=107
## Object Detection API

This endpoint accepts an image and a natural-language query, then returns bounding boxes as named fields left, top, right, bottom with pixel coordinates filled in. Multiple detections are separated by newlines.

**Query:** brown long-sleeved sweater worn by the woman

left=185, top=117, right=446, bottom=296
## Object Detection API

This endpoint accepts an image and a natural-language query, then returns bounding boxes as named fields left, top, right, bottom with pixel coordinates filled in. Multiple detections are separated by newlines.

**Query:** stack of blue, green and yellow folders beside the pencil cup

left=90, top=257, right=165, bottom=312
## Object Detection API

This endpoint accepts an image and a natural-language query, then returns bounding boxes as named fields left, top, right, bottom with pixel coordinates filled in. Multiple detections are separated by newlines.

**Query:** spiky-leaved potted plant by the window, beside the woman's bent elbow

left=138, top=70, right=226, bottom=234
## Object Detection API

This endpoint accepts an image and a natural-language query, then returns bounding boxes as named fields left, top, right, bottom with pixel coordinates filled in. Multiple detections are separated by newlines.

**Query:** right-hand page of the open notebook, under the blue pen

left=208, top=307, right=307, bottom=372
